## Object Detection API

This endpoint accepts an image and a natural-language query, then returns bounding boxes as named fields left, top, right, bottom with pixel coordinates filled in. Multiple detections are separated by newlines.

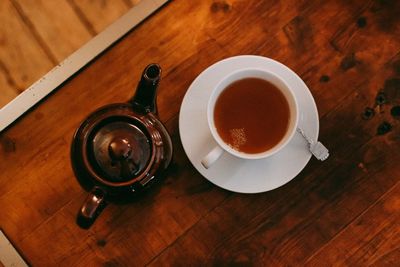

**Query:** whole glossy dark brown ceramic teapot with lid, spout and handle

left=71, top=64, right=172, bottom=228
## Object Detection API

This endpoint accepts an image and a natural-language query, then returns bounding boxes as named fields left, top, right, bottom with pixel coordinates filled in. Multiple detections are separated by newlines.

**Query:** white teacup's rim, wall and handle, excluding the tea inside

left=201, top=69, right=299, bottom=169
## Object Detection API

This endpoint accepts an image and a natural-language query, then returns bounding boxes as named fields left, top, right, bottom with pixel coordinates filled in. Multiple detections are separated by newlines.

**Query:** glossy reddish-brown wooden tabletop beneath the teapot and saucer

left=0, top=0, right=400, bottom=266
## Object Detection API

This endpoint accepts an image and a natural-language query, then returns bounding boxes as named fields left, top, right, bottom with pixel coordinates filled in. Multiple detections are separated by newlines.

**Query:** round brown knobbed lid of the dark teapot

left=86, top=117, right=152, bottom=183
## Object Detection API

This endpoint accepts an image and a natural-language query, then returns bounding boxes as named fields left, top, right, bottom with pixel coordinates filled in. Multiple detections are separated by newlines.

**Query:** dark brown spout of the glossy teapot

left=131, top=63, right=161, bottom=113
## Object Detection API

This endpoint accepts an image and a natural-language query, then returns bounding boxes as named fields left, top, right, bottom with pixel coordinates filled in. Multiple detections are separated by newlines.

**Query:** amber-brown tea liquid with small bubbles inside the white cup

left=214, top=78, right=290, bottom=154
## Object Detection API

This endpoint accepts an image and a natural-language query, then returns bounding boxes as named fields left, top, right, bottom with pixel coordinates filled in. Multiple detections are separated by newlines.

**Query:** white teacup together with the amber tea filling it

left=201, top=69, right=298, bottom=168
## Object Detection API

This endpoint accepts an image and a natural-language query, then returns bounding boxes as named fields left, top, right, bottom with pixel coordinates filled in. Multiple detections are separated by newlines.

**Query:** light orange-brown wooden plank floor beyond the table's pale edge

left=0, top=0, right=139, bottom=108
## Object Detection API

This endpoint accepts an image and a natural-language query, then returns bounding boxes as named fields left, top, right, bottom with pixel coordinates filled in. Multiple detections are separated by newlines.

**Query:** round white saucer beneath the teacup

left=179, top=56, right=319, bottom=193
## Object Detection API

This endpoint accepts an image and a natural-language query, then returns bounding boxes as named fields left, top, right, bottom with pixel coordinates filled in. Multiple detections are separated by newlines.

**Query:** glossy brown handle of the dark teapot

left=77, top=187, right=107, bottom=229
